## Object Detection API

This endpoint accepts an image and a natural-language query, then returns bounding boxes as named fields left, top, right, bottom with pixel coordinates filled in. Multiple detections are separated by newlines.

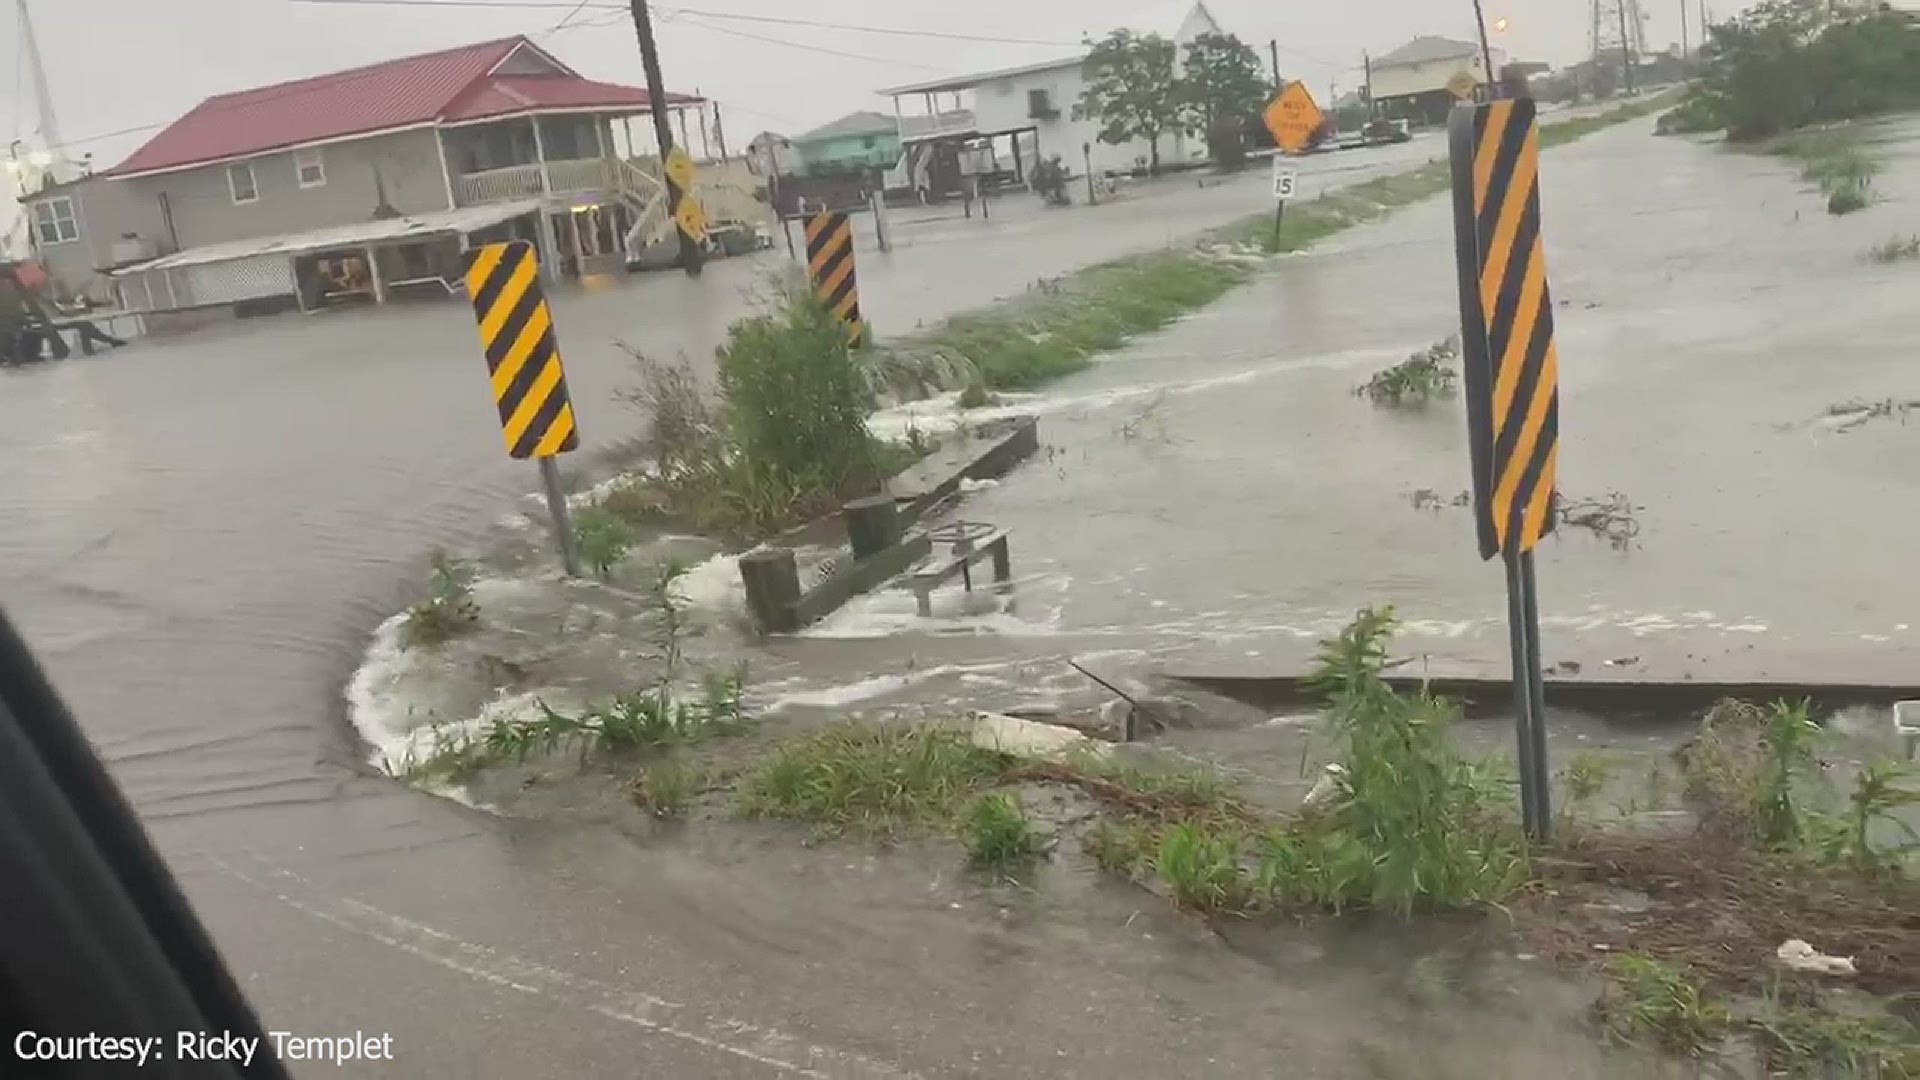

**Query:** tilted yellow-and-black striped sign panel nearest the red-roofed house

left=467, top=240, right=580, bottom=457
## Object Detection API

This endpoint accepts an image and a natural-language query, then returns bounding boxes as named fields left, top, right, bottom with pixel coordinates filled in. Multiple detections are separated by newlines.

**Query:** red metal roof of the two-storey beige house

left=104, top=37, right=697, bottom=177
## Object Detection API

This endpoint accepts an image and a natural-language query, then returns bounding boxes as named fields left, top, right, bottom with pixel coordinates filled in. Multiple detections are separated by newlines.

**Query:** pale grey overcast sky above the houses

left=0, top=0, right=1734, bottom=167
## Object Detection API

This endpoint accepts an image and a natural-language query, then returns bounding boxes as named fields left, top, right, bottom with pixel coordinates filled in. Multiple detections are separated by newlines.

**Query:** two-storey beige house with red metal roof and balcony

left=21, top=37, right=703, bottom=311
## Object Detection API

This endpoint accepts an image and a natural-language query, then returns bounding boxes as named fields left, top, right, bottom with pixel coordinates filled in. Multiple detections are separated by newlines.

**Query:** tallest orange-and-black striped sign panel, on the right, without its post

left=1450, top=98, right=1559, bottom=559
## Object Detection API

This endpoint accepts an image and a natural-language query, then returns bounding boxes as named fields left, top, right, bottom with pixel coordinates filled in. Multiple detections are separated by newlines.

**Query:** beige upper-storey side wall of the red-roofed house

left=129, top=129, right=447, bottom=248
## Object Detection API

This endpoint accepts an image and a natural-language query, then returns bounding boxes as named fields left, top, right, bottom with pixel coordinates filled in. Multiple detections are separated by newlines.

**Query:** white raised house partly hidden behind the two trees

left=879, top=2, right=1225, bottom=179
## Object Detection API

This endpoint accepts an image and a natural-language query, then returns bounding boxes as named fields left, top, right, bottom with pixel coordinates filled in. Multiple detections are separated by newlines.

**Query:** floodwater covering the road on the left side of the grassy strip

left=0, top=134, right=1605, bottom=1078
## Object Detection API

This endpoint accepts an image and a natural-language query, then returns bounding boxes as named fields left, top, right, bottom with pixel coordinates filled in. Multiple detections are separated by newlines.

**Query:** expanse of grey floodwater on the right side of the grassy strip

left=820, top=121, right=1920, bottom=699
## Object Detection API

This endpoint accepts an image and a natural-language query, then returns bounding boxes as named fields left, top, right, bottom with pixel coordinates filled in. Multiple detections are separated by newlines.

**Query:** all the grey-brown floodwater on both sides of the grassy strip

left=0, top=100, right=1920, bottom=1076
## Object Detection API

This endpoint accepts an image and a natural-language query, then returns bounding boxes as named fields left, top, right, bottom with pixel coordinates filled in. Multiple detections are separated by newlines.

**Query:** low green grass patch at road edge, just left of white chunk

left=739, top=724, right=1008, bottom=836
